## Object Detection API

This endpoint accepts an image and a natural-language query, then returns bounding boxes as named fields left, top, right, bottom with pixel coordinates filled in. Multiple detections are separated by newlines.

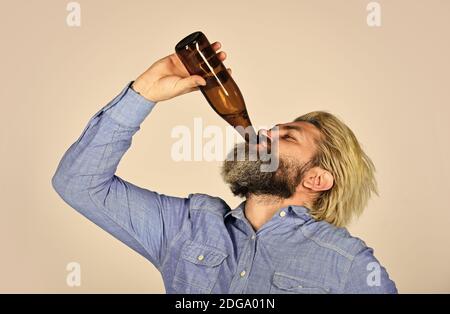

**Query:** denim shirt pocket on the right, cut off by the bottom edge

left=270, top=272, right=330, bottom=294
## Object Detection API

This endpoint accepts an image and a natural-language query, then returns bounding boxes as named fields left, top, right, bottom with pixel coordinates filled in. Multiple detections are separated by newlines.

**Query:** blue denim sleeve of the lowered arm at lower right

left=344, top=247, right=398, bottom=294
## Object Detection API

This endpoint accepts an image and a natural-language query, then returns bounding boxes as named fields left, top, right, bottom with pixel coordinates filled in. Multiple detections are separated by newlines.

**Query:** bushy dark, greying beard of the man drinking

left=222, top=143, right=311, bottom=198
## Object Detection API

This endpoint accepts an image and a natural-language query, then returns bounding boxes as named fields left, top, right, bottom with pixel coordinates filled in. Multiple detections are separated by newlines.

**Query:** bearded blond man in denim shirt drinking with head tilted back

left=52, top=42, right=397, bottom=293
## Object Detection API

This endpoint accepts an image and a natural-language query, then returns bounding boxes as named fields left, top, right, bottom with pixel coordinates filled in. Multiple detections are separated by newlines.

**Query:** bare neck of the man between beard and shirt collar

left=244, top=194, right=304, bottom=231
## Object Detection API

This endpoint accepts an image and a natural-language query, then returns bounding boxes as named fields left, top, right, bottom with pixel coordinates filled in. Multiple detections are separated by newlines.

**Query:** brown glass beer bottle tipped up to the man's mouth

left=175, top=32, right=257, bottom=142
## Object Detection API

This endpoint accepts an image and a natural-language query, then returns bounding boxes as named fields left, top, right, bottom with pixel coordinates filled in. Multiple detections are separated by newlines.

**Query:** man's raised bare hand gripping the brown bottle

left=133, top=42, right=231, bottom=102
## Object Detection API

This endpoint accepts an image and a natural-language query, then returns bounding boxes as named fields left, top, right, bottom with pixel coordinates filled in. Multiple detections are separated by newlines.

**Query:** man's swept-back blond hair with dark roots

left=294, top=111, right=378, bottom=227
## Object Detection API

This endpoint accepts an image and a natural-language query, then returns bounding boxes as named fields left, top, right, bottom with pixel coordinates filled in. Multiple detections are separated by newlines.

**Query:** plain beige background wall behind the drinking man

left=0, top=0, right=450, bottom=293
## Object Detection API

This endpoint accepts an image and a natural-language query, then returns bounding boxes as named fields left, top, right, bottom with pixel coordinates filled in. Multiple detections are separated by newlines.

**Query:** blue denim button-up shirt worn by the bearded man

left=52, top=85, right=397, bottom=293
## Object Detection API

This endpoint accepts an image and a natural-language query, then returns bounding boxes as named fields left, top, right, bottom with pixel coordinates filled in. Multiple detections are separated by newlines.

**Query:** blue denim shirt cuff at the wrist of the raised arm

left=104, top=82, right=156, bottom=128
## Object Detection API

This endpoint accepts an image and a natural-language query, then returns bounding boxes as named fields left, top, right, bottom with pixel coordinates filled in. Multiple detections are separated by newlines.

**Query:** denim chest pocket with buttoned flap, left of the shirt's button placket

left=172, top=241, right=228, bottom=293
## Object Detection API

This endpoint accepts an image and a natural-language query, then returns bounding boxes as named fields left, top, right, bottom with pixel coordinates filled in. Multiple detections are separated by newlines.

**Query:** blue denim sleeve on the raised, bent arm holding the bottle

left=52, top=83, right=189, bottom=269
